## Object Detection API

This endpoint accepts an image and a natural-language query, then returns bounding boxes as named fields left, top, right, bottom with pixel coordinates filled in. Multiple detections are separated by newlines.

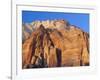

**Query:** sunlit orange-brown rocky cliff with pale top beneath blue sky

left=22, top=20, right=89, bottom=69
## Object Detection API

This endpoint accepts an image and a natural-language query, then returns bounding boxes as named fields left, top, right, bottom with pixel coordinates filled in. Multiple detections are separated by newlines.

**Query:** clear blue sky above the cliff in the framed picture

left=22, top=11, right=89, bottom=32
